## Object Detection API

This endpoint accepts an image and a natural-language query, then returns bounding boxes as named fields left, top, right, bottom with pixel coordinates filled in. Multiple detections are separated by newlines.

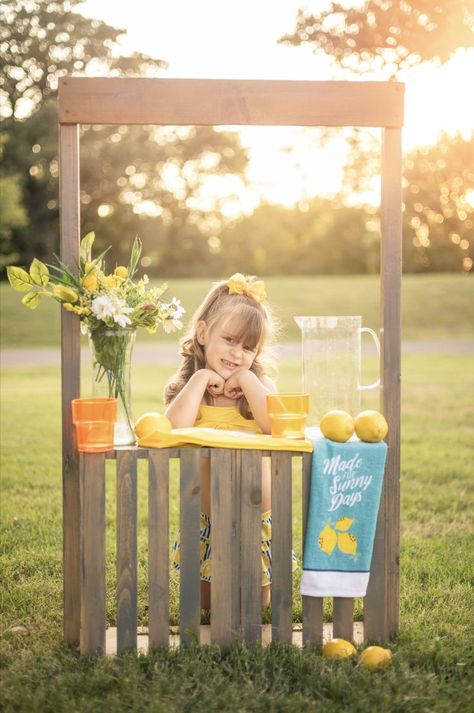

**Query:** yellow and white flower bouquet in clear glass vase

left=7, top=232, right=185, bottom=445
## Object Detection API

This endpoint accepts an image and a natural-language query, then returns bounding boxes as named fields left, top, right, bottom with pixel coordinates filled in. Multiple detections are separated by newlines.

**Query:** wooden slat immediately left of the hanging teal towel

left=272, top=451, right=293, bottom=644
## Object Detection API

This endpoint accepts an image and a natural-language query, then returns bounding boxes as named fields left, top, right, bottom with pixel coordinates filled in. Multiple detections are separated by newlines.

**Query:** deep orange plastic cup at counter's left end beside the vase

left=71, top=398, right=118, bottom=453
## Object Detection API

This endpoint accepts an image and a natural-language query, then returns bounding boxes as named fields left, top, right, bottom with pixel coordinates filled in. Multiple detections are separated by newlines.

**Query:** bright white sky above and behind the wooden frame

left=78, top=0, right=474, bottom=211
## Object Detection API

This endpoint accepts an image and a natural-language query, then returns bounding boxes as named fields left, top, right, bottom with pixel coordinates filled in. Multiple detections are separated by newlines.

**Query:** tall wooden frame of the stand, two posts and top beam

left=58, top=77, right=404, bottom=646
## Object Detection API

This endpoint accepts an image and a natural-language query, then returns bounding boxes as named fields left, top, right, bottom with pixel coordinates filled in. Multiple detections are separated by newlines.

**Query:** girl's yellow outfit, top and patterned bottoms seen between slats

left=172, top=404, right=297, bottom=587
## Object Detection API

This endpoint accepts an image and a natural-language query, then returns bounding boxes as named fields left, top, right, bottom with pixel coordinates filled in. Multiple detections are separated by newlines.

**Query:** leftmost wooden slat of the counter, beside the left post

left=80, top=453, right=105, bottom=654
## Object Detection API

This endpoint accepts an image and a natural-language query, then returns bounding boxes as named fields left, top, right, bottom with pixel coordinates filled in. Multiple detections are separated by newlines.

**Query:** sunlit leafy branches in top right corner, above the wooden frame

left=280, top=0, right=474, bottom=77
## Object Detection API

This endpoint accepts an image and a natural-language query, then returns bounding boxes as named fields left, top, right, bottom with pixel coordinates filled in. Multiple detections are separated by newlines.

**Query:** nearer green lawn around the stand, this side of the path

left=0, top=354, right=474, bottom=713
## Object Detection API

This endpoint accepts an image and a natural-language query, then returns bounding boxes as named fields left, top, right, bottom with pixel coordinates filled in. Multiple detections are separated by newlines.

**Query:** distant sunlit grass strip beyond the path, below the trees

left=0, top=274, right=474, bottom=348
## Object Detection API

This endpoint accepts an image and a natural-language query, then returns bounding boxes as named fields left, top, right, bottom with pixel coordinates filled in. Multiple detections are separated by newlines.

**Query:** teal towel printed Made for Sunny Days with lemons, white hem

left=301, top=438, right=387, bottom=597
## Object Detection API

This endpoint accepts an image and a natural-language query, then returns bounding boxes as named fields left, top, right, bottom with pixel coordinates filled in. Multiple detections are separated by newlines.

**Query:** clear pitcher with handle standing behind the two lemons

left=294, top=317, right=380, bottom=426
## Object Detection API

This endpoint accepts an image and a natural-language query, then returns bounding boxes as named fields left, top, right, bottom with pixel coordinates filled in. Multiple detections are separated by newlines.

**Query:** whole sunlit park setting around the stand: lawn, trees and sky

left=0, top=0, right=474, bottom=711
